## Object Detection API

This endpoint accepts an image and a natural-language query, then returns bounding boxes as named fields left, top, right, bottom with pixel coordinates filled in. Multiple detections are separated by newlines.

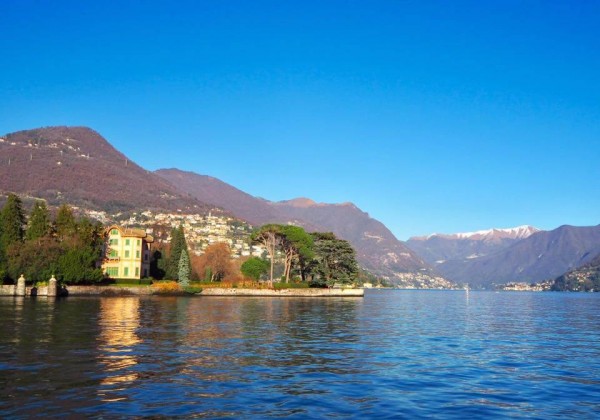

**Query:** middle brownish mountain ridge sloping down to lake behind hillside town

left=156, top=169, right=432, bottom=279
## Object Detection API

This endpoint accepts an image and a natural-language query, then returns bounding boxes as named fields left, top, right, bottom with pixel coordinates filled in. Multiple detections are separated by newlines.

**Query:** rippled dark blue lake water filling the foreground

left=0, top=290, right=600, bottom=418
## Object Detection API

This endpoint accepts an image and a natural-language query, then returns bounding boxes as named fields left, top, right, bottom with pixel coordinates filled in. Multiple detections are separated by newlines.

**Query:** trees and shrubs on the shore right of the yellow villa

left=150, top=224, right=360, bottom=287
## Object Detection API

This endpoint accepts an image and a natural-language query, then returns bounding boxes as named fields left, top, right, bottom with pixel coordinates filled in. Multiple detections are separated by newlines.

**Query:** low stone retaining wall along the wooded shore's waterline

left=0, top=285, right=365, bottom=297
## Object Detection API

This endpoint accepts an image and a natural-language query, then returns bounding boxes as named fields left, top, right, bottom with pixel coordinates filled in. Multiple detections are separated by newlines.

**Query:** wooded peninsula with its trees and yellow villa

left=0, top=194, right=366, bottom=291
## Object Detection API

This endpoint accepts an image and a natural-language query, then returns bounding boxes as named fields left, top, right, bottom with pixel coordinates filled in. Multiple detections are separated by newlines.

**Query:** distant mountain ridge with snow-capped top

left=406, top=226, right=539, bottom=265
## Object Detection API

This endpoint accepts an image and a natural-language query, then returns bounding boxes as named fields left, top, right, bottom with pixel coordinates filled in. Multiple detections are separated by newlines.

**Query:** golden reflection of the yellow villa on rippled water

left=98, top=297, right=141, bottom=401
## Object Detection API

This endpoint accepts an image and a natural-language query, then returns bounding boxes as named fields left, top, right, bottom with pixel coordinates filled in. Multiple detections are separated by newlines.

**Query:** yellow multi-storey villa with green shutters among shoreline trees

left=102, top=225, right=154, bottom=279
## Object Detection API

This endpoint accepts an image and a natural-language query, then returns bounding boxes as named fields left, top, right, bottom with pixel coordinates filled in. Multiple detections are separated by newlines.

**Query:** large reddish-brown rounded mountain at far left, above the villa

left=0, top=127, right=208, bottom=212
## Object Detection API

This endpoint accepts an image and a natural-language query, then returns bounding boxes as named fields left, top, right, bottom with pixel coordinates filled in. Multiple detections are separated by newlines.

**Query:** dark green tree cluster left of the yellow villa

left=0, top=194, right=104, bottom=284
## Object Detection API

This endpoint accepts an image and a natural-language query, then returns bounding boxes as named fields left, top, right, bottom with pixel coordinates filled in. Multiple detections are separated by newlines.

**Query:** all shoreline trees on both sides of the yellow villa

left=0, top=194, right=360, bottom=287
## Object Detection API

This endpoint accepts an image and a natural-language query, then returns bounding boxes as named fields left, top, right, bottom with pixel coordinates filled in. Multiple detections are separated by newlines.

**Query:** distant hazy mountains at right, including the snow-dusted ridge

left=408, top=225, right=600, bottom=287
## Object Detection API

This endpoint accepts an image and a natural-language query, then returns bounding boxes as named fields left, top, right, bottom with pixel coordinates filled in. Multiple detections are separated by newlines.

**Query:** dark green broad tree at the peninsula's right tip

left=312, top=233, right=358, bottom=287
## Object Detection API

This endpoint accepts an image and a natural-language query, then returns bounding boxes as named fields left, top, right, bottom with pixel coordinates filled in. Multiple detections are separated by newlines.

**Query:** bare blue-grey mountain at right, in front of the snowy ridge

left=436, top=225, right=600, bottom=287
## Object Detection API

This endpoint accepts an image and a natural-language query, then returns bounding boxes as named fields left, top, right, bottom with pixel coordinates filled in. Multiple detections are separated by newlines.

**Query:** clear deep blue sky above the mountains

left=0, top=0, right=600, bottom=240
